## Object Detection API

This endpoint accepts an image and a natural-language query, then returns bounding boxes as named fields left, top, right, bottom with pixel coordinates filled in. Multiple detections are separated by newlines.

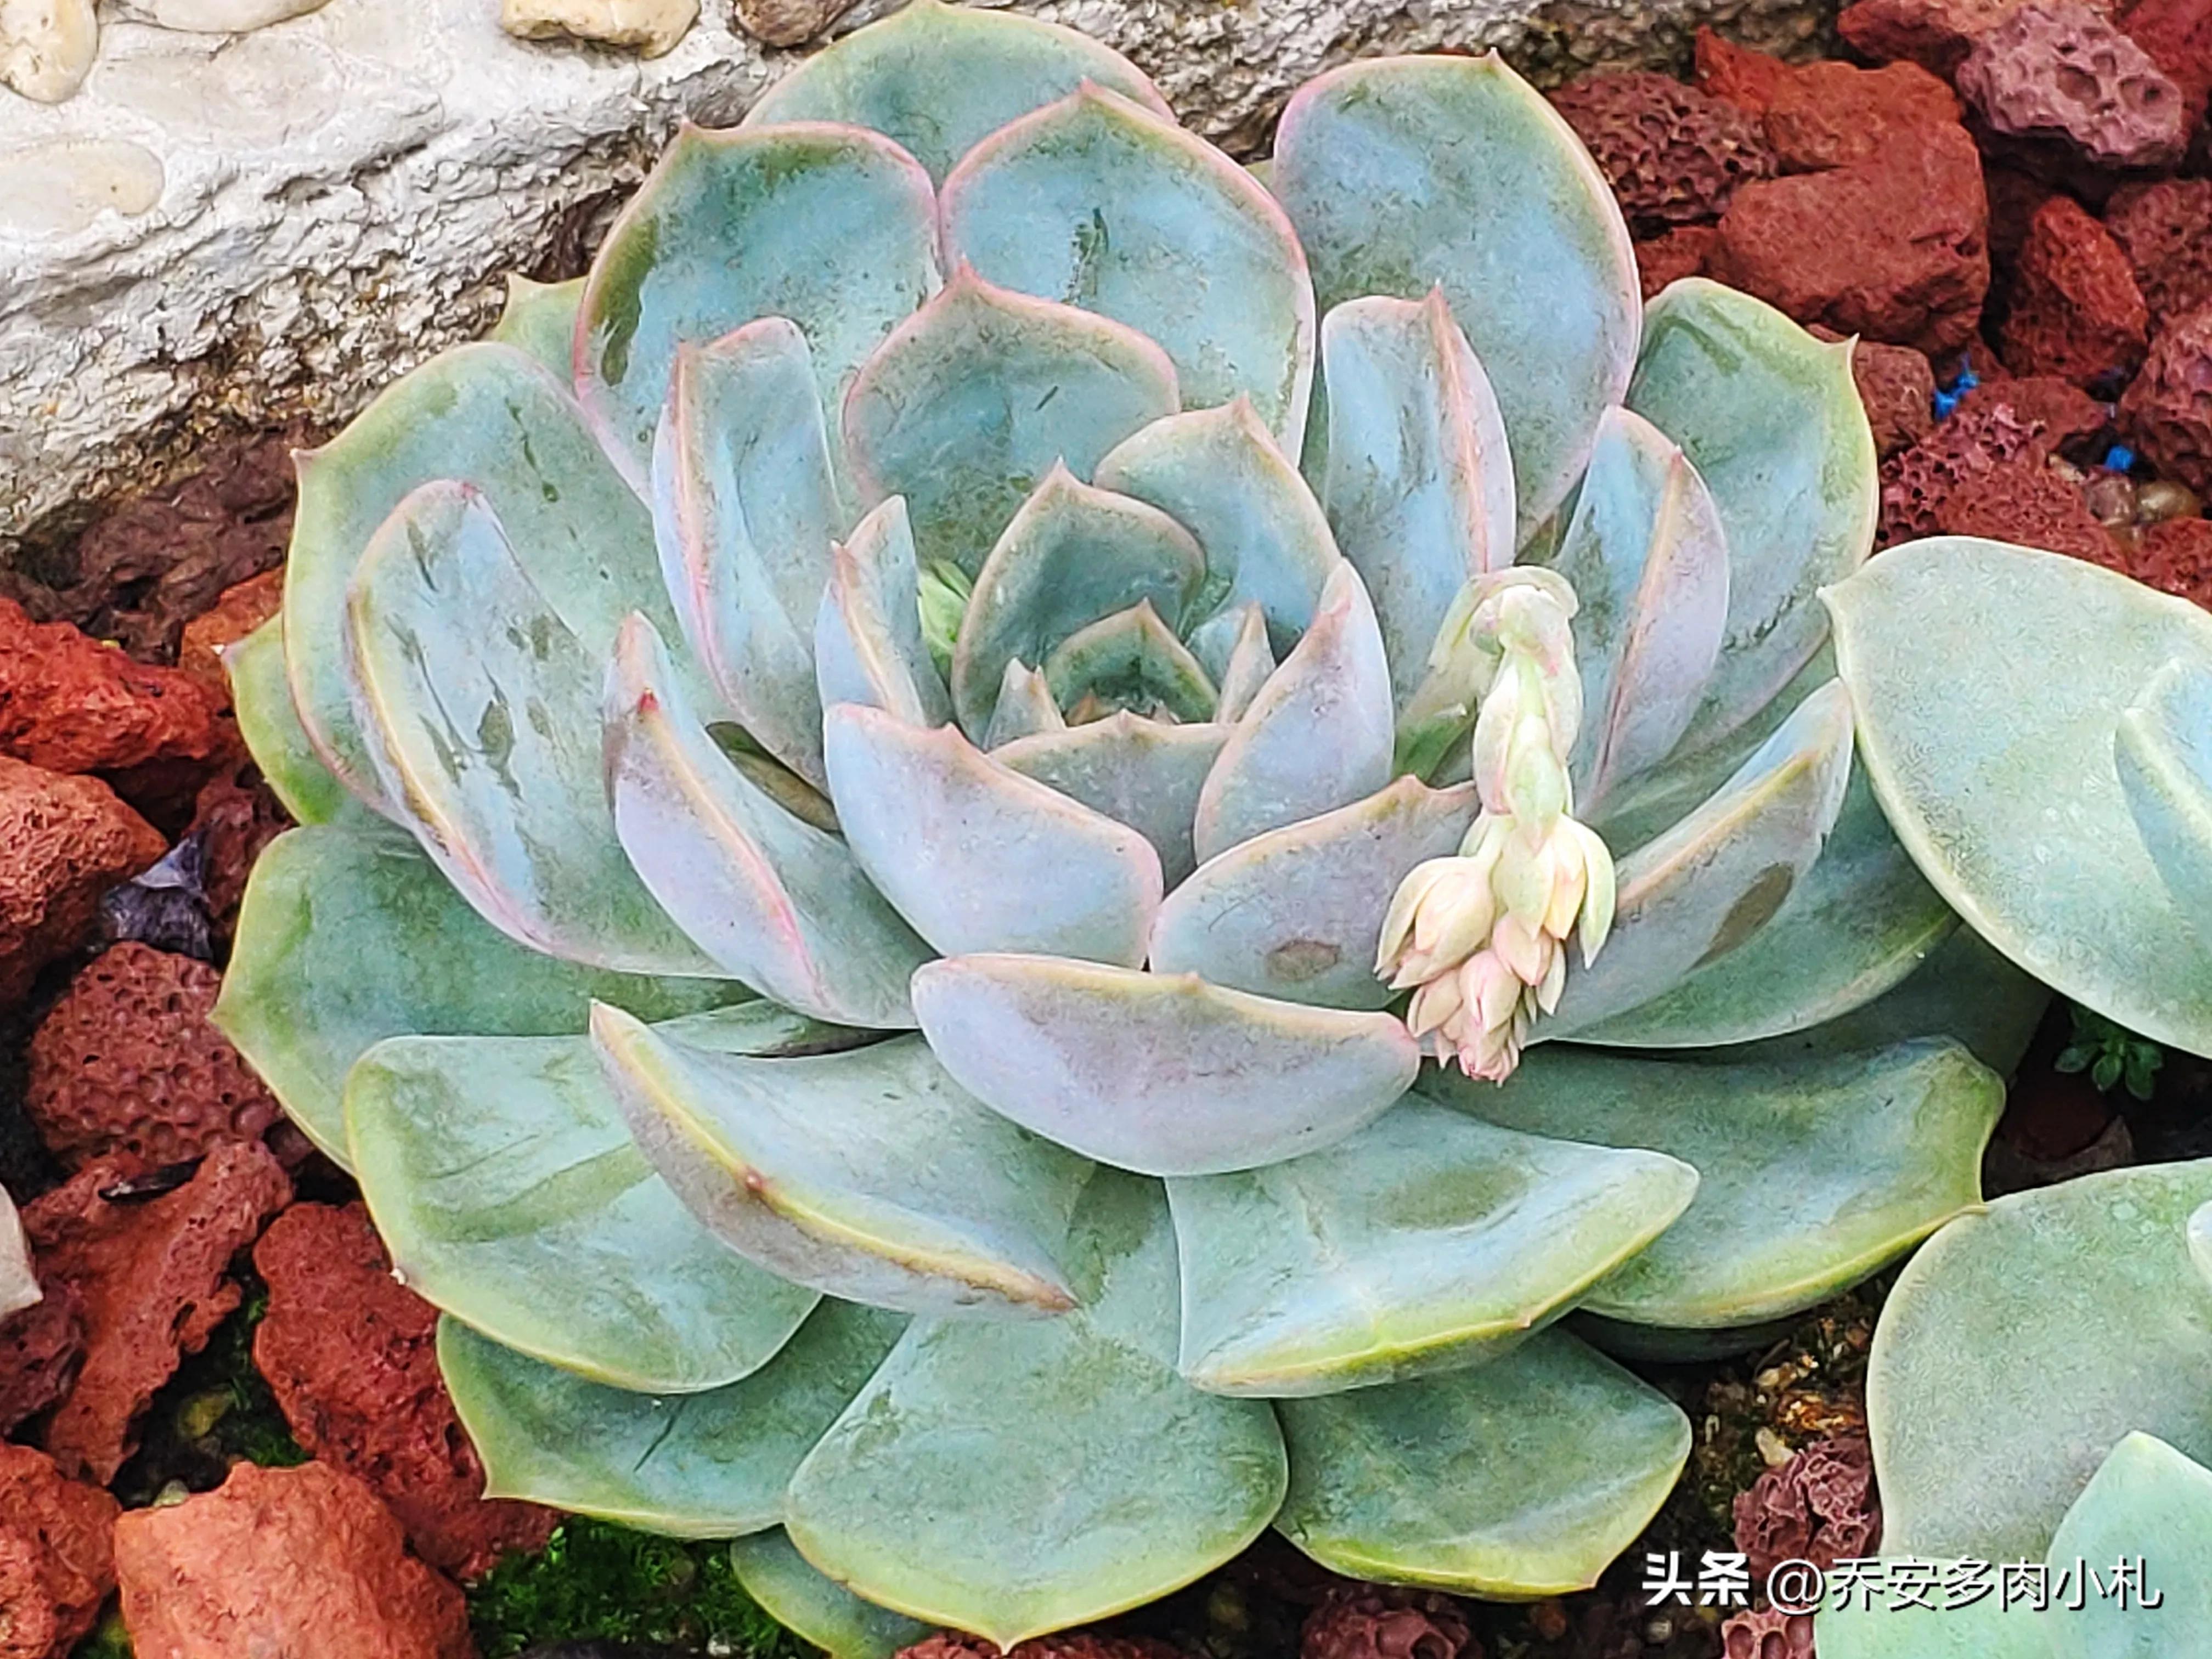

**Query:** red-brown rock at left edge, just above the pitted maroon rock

left=0, top=757, right=166, bottom=1005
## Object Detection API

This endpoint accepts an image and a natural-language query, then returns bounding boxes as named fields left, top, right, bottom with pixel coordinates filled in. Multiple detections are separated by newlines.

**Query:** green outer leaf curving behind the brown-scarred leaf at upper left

left=283, top=343, right=670, bottom=816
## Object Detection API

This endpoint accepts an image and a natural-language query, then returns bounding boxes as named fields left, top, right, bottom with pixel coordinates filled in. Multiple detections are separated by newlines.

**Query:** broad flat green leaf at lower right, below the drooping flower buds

left=1423, top=1040, right=2004, bottom=1329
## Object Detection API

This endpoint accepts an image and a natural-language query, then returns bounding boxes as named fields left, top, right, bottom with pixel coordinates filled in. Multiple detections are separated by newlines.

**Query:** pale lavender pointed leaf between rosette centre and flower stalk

left=1192, top=564, right=1393, bottom=862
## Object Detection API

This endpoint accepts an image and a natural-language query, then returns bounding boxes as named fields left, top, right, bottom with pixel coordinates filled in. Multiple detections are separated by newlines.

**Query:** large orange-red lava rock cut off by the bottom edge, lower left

left=115, top=1462, right=476, bottom=1659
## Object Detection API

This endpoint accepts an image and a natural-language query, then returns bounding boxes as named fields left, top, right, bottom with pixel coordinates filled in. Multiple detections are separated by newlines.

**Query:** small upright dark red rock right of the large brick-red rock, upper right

left=2002, top=197, right=2150, bottom=387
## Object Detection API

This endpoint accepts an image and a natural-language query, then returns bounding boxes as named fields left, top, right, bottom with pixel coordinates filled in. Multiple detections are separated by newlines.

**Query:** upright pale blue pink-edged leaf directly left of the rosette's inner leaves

left=652, top=327, right=849, bottom=787
